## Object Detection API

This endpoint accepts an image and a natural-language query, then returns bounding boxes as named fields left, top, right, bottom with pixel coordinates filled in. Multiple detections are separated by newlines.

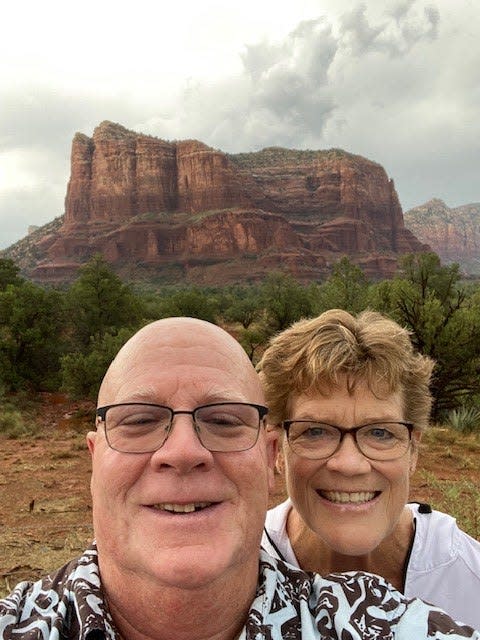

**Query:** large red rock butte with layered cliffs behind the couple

left=6, top=122, right=427, bottom=284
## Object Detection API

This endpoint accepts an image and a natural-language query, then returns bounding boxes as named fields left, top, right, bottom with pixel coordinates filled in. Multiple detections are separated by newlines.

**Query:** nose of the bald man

left=151, top=413, right=214, bottom=473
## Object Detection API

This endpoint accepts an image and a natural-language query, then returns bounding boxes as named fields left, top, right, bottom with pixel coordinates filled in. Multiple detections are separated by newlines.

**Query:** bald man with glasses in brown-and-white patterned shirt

left=0, top=318, right=480, bottom=640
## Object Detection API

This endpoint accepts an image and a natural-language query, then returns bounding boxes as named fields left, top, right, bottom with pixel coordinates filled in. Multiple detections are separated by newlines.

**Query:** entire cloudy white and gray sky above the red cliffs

left=0, top=0, right=480, bottom=248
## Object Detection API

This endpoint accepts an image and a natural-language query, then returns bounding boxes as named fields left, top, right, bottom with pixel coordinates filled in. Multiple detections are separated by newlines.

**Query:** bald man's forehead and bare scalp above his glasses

left=100, top=323, right=260, bottom=402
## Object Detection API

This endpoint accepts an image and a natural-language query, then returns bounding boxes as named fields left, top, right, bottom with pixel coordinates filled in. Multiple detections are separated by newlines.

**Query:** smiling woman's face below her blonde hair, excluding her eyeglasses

left=284, top=378, right=416, bottom=555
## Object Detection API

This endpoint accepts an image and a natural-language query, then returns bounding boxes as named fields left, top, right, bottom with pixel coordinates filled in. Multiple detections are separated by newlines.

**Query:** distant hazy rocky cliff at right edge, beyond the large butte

left=405, top=198, right=480, bottom=274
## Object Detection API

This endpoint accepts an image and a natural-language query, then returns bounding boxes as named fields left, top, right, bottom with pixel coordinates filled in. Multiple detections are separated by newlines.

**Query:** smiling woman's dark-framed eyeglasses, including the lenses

left=282, top=420, right=413, bottom=460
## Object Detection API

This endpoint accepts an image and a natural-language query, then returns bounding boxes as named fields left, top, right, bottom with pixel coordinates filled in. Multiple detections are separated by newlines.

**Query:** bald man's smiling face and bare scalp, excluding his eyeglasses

left=87, top=319, right=276, bottom=588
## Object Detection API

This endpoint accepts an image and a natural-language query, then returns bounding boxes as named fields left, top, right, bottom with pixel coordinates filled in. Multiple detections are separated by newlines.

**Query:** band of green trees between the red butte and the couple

left=0, top=254, right=480, bottom=431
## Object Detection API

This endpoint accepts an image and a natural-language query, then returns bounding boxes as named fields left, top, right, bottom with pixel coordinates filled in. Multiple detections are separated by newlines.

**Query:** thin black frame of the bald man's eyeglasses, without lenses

left=95, top=402, right=268, bottom=454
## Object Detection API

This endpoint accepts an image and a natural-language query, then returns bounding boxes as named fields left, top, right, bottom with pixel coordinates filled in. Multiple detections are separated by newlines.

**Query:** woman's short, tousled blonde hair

left=257, top=309, right=434, bottom=431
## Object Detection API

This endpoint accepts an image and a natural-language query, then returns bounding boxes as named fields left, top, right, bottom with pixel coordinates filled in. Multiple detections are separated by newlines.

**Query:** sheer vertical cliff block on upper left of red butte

left=65, top=122, right=248, bottom=228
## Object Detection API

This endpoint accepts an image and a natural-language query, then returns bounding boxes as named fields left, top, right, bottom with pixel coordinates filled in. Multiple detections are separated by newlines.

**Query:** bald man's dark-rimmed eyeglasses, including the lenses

left=96, top=402, right=268, bottom=453
